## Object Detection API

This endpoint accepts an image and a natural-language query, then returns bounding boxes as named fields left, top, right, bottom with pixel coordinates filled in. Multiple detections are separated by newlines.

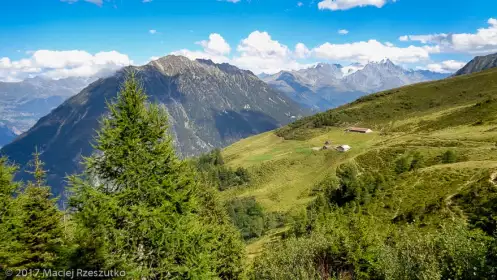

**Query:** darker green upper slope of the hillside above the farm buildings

left=277, top=66, right=497, bottom=139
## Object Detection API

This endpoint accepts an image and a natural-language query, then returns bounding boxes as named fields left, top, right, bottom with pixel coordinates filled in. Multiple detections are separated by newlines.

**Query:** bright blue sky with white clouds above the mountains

left=0, top=0, right=497, bottom=80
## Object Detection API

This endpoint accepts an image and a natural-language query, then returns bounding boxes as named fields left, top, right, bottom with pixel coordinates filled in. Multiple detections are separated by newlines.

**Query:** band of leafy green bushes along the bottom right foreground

left=251, top=209, right=497, bottom=280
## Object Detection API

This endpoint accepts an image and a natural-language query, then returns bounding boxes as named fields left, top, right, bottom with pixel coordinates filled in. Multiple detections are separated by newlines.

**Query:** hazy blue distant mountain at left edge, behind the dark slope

left=0, top=77, right=96, bottom=138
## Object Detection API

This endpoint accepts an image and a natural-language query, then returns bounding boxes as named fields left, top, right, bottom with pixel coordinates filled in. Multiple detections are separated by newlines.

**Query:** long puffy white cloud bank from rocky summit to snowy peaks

left=171, top=31, right=440, bottom=74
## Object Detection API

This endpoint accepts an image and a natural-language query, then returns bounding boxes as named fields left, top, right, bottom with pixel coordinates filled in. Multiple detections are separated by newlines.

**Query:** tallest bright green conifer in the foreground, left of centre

left=70, top=72, right=247, bottom=279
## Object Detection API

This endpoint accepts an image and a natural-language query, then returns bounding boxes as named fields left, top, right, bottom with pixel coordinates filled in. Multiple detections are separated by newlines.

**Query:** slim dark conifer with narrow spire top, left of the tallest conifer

left=10, top=152, right=64, bottom=269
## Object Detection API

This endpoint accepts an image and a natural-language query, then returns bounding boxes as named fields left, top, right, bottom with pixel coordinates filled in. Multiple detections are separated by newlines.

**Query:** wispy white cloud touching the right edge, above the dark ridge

left=399, top=18, right=497, bottom=54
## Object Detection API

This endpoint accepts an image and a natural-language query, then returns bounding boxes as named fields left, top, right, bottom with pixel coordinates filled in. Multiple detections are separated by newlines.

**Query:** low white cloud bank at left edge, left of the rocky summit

left=0, top=50, right=133, bottom=81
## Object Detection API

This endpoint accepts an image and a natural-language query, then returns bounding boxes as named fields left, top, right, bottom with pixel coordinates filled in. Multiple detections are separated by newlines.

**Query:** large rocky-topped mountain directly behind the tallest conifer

left=1, top=56, right=309, bottom=197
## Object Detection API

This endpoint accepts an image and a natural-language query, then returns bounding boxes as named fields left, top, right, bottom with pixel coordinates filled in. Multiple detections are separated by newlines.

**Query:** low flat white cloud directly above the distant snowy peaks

left=312, top=40, right=439, bottom=63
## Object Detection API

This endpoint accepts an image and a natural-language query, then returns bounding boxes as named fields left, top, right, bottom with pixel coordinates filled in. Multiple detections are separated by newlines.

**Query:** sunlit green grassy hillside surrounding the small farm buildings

left=218, top=69, right=497, bottom=270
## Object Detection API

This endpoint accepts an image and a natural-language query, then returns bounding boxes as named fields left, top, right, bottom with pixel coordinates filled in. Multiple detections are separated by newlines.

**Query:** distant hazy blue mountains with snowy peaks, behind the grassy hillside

left=263, top=59, right=448, bottom=111
